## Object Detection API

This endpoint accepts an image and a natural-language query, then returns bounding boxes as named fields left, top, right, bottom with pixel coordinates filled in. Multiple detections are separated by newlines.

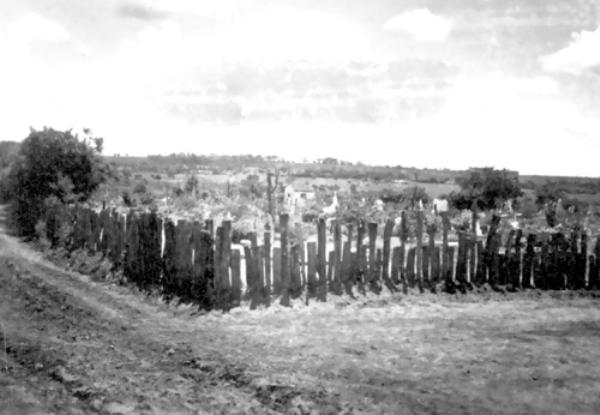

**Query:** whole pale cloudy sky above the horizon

left=0, top=0, right=600, bottom=177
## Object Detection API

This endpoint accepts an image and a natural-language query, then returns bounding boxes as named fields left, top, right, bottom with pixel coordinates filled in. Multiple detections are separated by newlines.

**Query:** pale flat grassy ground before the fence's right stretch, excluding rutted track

left=192, top=293, right=600, bottom=414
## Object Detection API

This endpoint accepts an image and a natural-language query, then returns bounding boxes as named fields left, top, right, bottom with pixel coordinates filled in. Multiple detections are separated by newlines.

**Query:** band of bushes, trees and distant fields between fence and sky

left=0, top=133, right=600, bottom=234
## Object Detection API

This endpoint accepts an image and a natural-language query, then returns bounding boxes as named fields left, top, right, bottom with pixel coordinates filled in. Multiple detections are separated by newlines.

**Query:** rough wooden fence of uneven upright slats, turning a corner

left=46, top=206, right=600, bottom=310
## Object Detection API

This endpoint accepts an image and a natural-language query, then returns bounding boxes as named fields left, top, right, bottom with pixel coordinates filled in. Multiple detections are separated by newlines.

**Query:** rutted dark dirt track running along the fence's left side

left=0, top=210, right=332, bottom=414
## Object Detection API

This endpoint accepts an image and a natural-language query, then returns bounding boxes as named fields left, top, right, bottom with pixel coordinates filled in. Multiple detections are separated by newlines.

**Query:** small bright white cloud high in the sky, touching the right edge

left=540, top=27, right=600, bottom=74
